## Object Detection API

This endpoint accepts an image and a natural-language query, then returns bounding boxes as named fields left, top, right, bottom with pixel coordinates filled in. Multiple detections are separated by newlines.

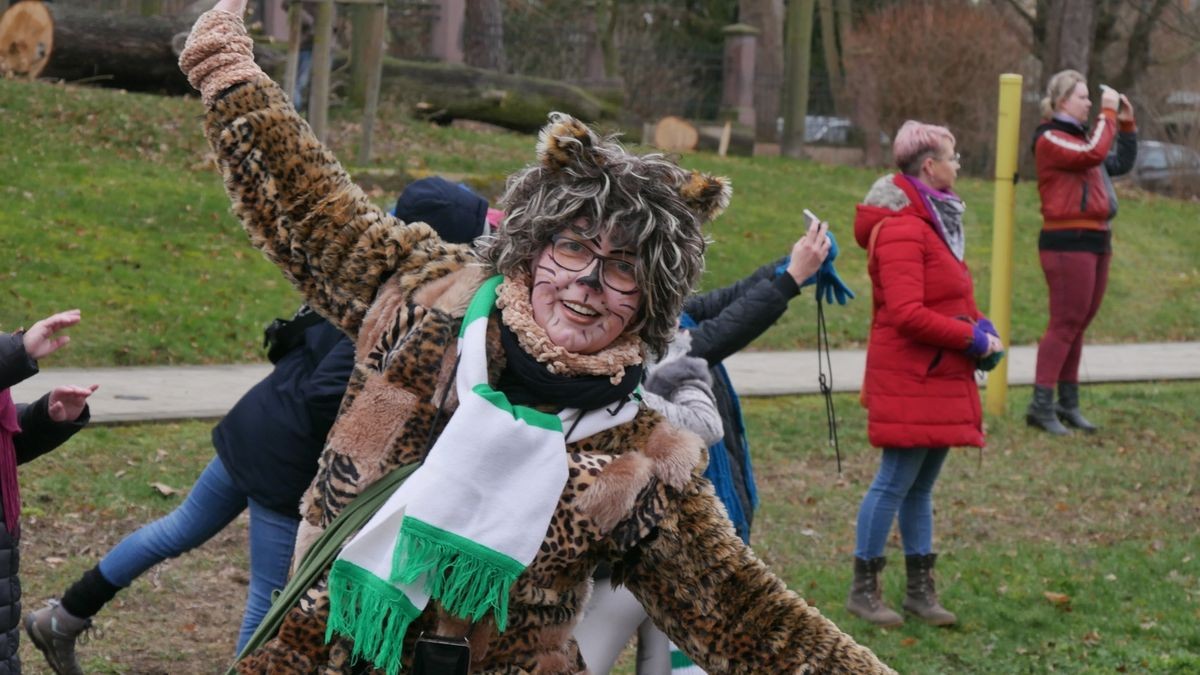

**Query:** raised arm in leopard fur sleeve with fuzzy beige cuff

left=180, top=5, right=468, bottom=335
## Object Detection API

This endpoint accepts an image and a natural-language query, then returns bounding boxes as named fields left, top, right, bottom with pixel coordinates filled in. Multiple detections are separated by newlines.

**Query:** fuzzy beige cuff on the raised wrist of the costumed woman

left=179, top=10, right=265, bottom=107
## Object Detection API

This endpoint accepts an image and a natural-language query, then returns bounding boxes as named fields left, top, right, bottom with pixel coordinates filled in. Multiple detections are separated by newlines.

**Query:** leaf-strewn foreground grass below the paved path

left=22, top=383, right=1200, bottom=675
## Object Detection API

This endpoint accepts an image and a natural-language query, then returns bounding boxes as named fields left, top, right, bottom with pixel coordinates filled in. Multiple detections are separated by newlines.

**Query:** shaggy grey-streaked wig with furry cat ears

left=479, top=113, right=731, bottom=354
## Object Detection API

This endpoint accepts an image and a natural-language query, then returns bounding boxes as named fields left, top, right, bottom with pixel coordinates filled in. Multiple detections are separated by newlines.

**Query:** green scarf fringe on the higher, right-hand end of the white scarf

left=391, top=518, right=524, bottom=632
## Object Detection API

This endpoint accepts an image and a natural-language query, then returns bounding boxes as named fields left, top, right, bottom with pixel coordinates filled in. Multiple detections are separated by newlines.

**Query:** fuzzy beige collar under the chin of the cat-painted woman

left=496, top=273, right=642, bottom=384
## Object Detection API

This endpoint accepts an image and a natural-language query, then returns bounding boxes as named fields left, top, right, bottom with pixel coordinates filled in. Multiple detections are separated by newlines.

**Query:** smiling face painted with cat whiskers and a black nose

left=530, top=219, right=642, bottom=354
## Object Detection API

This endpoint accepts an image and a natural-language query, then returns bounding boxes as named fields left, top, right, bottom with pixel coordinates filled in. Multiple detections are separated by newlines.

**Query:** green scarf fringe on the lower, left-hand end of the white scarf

left=325, top=560, right=421, bottom=675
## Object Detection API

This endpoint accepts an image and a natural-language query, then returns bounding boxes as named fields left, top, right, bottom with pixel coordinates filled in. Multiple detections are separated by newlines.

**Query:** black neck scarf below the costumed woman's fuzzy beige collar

left=497, top=322, right=642, bottom=411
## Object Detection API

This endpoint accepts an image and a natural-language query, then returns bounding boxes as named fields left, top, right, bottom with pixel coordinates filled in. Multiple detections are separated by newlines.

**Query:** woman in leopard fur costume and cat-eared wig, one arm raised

left=180, top=0, right=890, bottom=675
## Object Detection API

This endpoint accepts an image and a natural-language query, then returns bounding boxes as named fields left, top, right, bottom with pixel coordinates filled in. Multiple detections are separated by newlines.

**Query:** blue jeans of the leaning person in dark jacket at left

left=100, top=458, right=300, bottom=652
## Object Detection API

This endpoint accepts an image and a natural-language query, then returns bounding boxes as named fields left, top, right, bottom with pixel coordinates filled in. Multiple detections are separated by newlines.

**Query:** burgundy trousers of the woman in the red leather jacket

left=1034, top=251, right=1112, bottom=388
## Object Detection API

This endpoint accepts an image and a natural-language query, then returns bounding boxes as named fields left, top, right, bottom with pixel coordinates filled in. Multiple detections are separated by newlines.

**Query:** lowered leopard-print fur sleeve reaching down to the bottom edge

left=624, top=478, right=894, bottom=675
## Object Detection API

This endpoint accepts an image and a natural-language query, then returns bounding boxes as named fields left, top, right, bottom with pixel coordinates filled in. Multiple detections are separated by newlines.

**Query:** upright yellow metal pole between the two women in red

left=986, top=73, right=1021, bottom=416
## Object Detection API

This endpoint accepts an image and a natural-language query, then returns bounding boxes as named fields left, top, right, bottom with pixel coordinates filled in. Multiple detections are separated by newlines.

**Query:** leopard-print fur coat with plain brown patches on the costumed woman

left=199, top=78, right=890, bottom=675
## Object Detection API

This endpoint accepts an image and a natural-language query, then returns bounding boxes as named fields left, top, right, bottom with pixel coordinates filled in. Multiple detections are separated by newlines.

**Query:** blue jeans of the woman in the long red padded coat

left=854, top=448, right=949, bottom=560
